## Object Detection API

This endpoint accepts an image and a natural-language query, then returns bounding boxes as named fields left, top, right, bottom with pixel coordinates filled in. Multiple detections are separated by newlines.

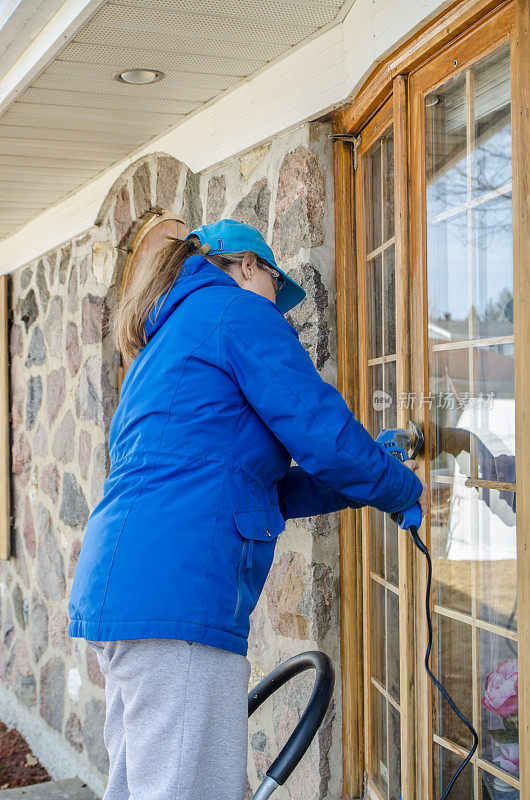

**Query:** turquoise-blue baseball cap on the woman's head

left=185, top=219, right=306, bottom=314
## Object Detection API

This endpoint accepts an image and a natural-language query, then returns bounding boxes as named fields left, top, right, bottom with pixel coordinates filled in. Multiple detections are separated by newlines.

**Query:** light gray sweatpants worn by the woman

left=89, top=639, right=250, bottom=800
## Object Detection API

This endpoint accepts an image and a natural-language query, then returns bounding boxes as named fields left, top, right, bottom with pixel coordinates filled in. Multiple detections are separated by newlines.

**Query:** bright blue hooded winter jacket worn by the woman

left=68, top=256, right=422, bottom=655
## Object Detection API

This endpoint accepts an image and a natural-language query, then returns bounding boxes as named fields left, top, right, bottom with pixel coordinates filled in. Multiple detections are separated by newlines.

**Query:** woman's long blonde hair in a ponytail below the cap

left=109, top=234, right=268, bottom=365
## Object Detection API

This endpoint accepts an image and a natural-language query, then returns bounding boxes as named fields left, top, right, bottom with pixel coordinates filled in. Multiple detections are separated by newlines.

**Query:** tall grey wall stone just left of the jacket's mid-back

left=75, top=356, right=116, bottom=430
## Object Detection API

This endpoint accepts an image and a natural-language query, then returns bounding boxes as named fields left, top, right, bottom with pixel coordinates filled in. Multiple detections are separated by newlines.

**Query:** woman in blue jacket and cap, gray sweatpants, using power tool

left=69, top=219, right=426, bottom=800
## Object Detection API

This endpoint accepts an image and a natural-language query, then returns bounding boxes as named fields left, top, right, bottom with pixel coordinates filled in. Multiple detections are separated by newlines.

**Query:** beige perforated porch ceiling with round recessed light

left=0, top=0, right=351, bottom=239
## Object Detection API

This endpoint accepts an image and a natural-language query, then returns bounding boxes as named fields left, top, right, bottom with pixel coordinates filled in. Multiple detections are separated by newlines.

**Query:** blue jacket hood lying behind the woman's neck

left=144, top=255, right=241, bottom=339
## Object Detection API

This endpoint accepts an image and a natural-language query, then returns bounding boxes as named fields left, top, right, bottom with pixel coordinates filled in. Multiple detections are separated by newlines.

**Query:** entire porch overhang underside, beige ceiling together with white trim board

left=0, top=0, right=446, bottom=274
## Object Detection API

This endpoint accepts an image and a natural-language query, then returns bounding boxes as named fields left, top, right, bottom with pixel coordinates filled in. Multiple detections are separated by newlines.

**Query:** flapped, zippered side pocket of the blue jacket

left=229, top=507, right=285, bottom=619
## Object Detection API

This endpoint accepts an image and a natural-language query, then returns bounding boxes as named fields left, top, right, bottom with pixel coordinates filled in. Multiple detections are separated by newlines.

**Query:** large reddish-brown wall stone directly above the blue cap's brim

left=272, top=146, right=326, bottom=259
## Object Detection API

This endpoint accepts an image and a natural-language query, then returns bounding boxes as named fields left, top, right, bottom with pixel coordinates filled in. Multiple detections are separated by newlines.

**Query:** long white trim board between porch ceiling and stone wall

left=0, top=0, right=447, bottom=274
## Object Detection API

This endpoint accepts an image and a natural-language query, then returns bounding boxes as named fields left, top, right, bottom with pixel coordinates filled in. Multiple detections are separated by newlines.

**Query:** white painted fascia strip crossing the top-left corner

left=0, top=0, right=105, bottom=114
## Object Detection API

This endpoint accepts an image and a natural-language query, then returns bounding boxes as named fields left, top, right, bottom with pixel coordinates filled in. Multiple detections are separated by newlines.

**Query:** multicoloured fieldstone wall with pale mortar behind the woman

left=0, top=122, right=342, bottom=800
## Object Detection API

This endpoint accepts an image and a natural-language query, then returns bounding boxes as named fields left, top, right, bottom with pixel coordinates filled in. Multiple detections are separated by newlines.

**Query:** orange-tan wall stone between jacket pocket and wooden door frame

left=265, top=550, right=311, bottom=639
